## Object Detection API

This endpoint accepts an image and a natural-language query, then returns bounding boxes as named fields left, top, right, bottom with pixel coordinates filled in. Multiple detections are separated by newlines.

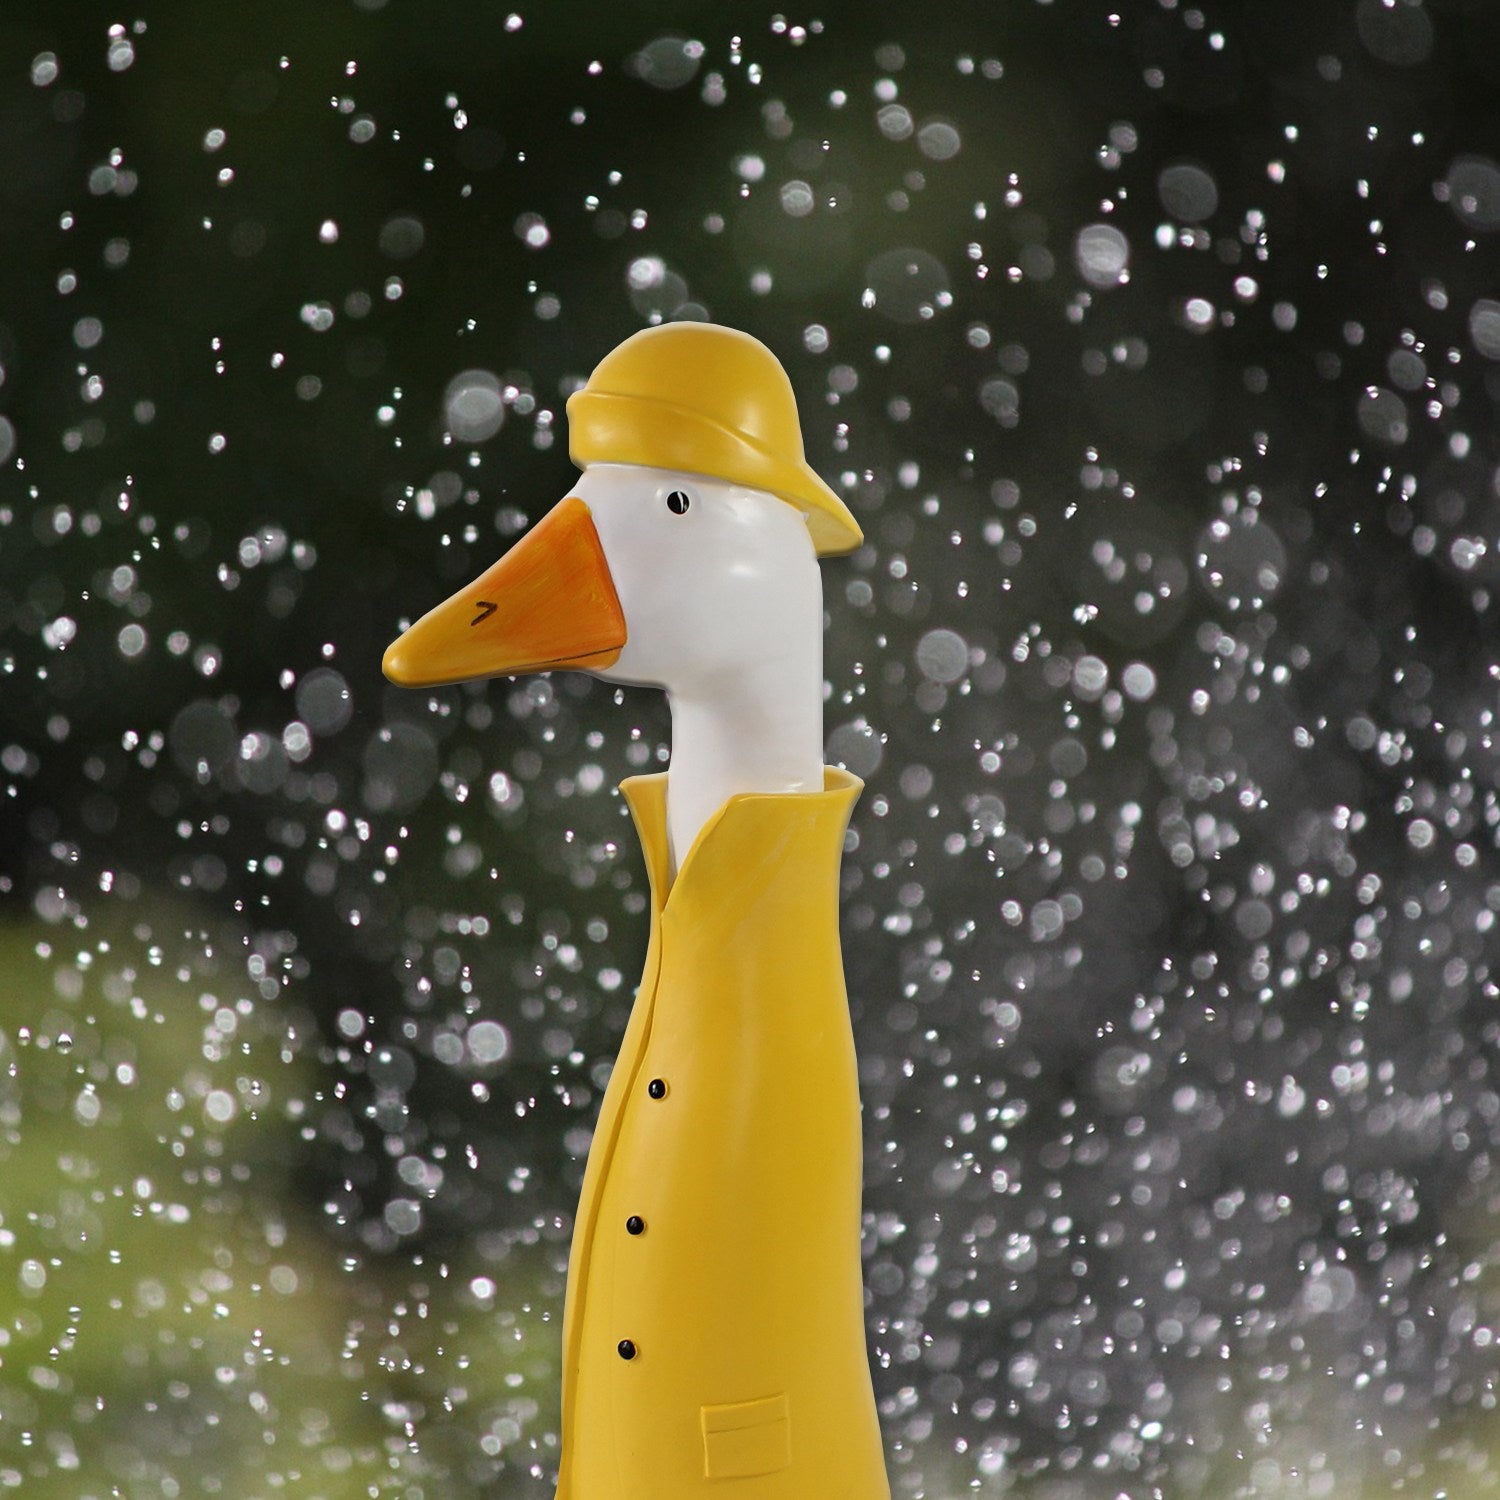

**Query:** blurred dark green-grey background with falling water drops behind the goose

left=0, top=0, right=1500, bottom=1500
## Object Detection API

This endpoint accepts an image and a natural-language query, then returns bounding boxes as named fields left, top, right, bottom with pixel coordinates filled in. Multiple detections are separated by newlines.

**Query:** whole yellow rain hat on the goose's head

left=567, top=323, right=864, bottom=557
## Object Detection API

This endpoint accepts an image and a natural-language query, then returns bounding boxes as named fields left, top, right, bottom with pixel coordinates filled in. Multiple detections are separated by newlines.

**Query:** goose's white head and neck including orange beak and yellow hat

left=384, top=323, right=861, bottom=876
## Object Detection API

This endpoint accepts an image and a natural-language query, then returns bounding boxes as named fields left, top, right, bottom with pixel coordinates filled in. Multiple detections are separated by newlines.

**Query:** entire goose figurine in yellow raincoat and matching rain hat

left=384, top=323, right=890, bottom=1500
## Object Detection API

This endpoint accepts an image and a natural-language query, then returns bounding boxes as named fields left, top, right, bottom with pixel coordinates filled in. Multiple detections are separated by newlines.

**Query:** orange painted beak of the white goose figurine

left=381, top=495, right=626, bottom=687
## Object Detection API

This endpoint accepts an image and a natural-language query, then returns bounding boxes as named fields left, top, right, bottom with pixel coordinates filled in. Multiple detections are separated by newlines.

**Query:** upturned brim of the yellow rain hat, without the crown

left=567, top=389, right=864, bottom=557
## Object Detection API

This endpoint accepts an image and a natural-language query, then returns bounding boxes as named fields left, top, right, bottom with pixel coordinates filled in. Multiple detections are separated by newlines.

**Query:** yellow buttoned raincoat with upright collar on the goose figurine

left=558, top=770, right=890, bottom=1500
